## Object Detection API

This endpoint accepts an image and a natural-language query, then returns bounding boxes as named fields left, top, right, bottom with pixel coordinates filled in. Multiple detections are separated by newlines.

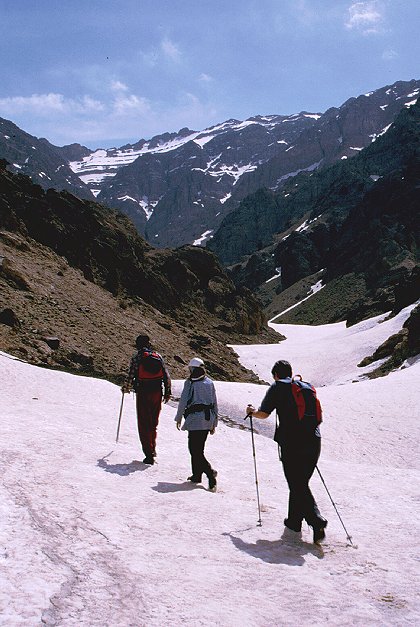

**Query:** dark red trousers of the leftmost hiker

left=136, top=388, right=162, bottom=458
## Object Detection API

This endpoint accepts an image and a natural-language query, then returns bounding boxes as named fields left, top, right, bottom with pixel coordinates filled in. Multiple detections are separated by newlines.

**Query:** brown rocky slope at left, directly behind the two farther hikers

left=0, top=162, right=278, bottom=381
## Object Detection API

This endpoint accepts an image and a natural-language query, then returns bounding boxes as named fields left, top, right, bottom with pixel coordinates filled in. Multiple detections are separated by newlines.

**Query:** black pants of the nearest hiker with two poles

left=281, top=437, right=325, bottom=528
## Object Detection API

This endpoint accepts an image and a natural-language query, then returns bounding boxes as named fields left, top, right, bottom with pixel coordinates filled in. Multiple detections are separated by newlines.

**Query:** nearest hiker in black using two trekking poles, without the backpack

left=246, top=360, right=327, bottom=543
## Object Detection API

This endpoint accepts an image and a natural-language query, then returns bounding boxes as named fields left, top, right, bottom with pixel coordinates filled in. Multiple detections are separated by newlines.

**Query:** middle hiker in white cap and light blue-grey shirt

left=175, top=357, right=217, bottom=492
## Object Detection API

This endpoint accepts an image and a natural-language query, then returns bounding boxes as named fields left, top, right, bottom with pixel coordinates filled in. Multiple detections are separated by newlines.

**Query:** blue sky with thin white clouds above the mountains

left=0, top=0, right=420, bottom=148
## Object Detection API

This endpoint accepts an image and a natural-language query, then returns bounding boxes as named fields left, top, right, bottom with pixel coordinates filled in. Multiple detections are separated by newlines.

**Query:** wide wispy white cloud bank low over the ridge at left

left=0, top=86, right=220, bottom=147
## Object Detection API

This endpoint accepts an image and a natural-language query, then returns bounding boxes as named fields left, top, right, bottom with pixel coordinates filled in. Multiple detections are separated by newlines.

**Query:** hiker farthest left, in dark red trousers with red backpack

left=121, top=335, right=171, bottom=465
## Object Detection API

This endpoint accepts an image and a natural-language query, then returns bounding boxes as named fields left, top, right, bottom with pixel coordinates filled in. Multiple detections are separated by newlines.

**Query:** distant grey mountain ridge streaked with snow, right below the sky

left=0, top=80, right=420, bottom=251
